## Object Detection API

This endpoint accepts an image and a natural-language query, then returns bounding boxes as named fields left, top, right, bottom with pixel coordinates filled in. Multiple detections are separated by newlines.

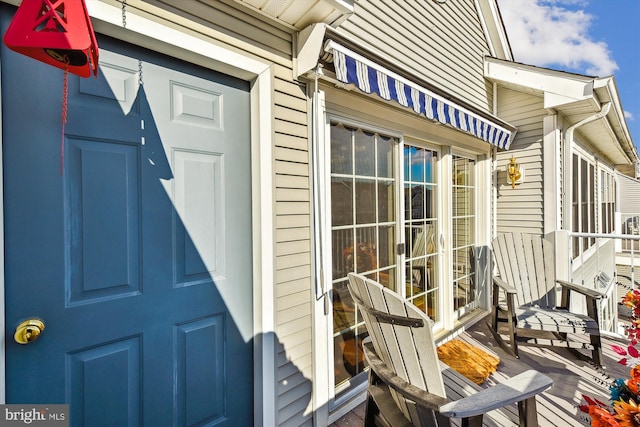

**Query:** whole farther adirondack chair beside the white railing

left=490, top=233, right=604, bottom=366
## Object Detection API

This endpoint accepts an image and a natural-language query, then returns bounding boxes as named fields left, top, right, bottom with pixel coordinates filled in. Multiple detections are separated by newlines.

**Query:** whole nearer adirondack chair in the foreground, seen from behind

left=348, top=273, right=553, bottom=427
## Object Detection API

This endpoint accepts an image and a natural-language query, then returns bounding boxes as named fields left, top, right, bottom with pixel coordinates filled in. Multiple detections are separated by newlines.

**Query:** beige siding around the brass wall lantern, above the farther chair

left=497, top=87, right=546, bottom=235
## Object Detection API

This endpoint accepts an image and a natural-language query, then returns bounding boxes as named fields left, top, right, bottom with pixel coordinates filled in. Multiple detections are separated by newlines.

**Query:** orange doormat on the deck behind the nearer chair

left=438, top=340, right=500, bottom=385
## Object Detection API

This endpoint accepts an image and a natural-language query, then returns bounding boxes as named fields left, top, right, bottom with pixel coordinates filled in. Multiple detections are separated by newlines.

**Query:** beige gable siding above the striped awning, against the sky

left=338, top=0, right=490, bottom=112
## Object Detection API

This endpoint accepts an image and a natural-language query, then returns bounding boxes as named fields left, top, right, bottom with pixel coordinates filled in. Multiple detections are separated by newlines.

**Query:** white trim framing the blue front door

left=0, top=0, right=276, bottom=426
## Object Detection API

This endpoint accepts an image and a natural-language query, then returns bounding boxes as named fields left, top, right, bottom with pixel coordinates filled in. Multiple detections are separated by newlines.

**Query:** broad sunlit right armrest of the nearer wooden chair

left=440, top=370, right=553, bottom=418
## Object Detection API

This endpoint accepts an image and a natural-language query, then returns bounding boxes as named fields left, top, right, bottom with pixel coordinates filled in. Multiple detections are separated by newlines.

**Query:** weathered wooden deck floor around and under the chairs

left=331, top=314, right=629, bottom=427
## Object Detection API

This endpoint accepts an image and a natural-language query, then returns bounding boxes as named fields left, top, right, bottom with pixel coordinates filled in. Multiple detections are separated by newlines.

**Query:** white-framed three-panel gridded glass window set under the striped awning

left=320, top=116, right=488, bottom=410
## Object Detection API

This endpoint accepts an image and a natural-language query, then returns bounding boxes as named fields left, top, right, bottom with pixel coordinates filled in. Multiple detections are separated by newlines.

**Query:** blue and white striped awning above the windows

left=325, top=40, right=514, bottom=149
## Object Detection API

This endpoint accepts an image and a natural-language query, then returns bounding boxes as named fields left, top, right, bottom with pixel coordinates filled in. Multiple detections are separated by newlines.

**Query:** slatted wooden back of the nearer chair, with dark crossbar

left=349, top=273, right=446, bottom=423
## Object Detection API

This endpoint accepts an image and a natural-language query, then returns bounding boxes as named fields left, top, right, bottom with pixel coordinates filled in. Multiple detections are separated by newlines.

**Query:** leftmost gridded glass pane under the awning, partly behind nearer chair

left=331, top=123, right=397, bottom=392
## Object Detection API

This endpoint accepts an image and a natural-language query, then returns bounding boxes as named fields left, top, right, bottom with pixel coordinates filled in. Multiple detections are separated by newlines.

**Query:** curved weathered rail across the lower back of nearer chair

left=363, top=342, right=448, bottom=410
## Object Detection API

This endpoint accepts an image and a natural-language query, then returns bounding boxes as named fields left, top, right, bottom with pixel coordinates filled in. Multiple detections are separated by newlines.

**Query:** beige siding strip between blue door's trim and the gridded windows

left=115, top=0, right=313, bottom=426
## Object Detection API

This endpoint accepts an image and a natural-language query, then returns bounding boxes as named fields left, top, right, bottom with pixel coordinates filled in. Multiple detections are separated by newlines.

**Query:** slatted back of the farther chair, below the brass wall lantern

left=493, top=233, right=556, bottom=308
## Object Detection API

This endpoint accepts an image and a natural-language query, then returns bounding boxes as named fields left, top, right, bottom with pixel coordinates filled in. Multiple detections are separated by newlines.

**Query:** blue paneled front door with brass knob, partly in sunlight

left=0, top=6, right=253, bottom=427
